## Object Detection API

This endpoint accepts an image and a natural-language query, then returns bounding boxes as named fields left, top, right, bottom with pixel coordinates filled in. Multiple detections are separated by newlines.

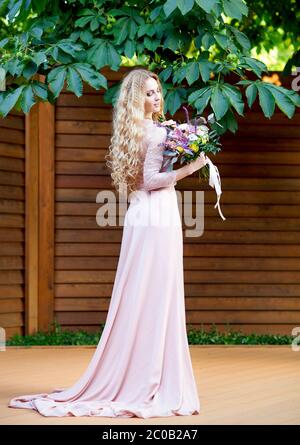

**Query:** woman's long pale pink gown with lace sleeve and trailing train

left=8, top=119, right=200, bottom=418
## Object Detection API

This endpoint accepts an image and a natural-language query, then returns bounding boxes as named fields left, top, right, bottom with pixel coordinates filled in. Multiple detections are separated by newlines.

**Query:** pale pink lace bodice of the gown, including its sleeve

left=139, top=119, right=177, bottom=191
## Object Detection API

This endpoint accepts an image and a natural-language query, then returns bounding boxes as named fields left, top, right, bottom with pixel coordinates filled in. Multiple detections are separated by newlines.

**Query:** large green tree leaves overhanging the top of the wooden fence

left=0, top=0, right=299, bottom=133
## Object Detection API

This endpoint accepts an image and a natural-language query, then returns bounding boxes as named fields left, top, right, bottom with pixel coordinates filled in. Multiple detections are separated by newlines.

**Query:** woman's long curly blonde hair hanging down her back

left=105, top=68, right=165, bottom=194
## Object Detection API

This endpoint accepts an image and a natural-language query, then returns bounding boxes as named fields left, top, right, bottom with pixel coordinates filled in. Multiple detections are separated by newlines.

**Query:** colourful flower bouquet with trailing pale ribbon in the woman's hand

left=159, top=107, right=226, bottom=220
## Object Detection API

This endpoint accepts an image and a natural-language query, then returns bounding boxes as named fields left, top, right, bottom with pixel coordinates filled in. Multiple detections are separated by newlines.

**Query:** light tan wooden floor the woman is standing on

left=0, top=346, right=300, bottom=425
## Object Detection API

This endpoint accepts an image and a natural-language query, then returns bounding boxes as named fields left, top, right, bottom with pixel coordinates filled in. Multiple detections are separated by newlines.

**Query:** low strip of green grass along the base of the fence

left=6, top=322, right=294, bottom=346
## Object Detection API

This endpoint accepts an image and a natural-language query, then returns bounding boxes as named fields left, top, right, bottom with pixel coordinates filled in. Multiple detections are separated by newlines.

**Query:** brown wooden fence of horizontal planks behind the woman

left=0, top=68, right=300, bottom=338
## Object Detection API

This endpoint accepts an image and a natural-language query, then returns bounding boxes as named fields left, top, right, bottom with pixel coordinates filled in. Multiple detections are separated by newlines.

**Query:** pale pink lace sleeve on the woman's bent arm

left=143, top=127, right=177, bottom=191
